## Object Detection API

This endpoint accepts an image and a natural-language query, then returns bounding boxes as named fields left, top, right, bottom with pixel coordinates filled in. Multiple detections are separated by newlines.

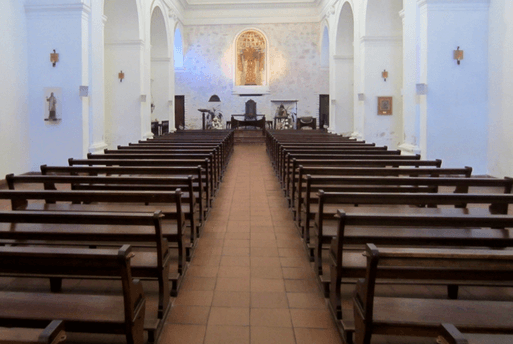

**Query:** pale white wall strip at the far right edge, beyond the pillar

left=488, top=0, right=513, bottom=177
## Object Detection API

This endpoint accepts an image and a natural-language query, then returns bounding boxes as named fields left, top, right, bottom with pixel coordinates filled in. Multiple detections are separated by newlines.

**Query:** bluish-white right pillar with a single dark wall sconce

left=421, top=1, right=488, bottom=174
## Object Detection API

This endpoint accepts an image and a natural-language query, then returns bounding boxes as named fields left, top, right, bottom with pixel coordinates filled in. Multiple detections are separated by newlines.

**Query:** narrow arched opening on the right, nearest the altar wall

left=330, top=2, right=354, bottom=135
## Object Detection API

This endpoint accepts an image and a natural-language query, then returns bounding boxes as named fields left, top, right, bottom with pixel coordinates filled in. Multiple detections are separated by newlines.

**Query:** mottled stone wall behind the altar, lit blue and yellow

left=175, top=23, right=329, bottom=129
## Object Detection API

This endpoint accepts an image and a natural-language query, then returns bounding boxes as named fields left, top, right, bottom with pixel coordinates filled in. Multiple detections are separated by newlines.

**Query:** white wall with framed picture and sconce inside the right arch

left=361, top=0, right=403, bottom=148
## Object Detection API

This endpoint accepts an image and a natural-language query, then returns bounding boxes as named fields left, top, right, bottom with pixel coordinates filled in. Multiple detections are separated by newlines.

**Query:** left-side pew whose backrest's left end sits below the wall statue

left=41, top=165, right=211, bottom=218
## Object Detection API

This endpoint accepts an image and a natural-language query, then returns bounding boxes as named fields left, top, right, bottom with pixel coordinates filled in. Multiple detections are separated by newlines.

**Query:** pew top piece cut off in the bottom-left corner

left=0, top=320, right=66, bottom=344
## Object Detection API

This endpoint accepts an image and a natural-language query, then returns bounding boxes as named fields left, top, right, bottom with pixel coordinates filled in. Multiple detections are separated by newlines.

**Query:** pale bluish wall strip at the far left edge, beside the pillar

left=0, top=0, right=30, bottom=179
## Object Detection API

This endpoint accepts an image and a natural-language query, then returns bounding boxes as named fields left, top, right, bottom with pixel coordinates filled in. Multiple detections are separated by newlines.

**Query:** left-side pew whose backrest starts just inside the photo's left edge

left=5, top=174, right=203, bottom=250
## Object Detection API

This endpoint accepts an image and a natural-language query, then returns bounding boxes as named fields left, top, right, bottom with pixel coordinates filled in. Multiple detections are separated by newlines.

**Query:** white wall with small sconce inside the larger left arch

left=104, top=0, right=144, bottom=147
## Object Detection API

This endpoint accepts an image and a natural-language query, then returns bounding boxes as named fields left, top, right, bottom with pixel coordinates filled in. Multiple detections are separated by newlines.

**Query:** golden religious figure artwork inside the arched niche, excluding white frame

left=235, top=30, right=266, bottom=86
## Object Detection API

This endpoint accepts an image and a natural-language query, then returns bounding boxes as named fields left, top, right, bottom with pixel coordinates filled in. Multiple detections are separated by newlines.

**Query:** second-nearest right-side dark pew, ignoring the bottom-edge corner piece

left=330, top=208, right=513, bottom=342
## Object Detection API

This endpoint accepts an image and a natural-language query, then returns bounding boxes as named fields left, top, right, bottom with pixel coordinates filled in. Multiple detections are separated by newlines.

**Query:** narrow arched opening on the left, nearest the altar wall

left=150, top=7, right=171, bottom=129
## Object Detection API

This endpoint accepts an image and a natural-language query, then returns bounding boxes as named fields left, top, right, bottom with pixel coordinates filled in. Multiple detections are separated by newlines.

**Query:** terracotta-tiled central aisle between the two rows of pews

left=160, top=145, right=340, bottom=344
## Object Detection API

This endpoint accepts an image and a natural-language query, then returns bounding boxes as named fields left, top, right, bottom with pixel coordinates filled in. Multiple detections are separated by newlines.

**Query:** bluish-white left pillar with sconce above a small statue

left=26, top=0, right=89, bottom=170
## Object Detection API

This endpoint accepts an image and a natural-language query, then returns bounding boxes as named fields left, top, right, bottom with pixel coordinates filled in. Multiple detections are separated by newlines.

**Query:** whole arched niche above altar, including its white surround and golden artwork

left=233, top=28, right=269, bottom=94
